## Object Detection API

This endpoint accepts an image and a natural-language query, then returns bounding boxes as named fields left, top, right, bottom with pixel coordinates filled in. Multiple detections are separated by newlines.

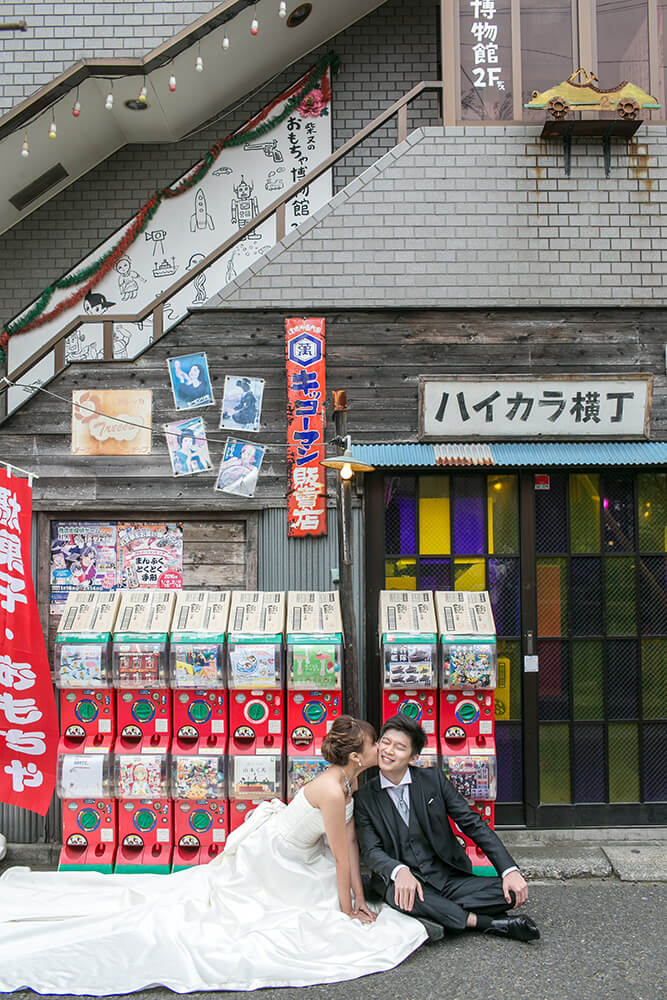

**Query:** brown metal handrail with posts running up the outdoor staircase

left=0, top=80, right=443, bottom=423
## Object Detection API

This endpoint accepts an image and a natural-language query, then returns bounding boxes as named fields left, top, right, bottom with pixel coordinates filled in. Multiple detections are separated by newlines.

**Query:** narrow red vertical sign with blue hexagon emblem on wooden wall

left=285, top=319, right=327, bottom=538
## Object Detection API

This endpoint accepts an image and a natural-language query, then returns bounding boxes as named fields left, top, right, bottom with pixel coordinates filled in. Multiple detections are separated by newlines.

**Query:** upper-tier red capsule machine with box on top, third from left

left=169, top=590, right=229, bottom=753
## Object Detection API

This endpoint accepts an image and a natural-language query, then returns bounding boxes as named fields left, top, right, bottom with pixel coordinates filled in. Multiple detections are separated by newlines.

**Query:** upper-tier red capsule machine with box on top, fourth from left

left=227, top=591, right=285, bottom=754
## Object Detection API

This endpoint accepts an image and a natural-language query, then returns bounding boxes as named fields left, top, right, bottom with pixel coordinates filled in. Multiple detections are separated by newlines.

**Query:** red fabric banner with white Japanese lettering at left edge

left=0, top=469, right=58, bottom=816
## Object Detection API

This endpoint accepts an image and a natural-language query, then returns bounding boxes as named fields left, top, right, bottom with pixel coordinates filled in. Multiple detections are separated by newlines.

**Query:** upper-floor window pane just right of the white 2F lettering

left=521, top=0, right=577, bottom=121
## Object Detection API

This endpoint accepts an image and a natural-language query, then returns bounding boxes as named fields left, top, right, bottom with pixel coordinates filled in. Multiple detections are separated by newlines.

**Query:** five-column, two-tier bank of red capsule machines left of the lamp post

left=55, top=591, right=342, bottom=872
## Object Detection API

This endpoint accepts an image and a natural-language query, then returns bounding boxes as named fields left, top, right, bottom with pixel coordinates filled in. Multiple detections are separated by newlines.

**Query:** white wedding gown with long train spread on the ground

left=0, top=791, right=427, bottom=996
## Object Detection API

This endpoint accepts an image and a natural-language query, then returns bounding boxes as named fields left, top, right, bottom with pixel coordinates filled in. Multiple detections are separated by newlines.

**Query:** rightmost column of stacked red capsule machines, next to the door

left=435, top=591, right=497, bottom=875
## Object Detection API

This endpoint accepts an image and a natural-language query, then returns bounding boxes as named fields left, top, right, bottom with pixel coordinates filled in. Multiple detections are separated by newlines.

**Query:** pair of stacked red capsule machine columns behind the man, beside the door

left=379, top=590, right=497, bottom=875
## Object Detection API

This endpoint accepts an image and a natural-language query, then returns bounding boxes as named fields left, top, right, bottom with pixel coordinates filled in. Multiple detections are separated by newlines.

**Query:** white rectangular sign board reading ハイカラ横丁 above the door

left=419, top=375, right=653, bottom=440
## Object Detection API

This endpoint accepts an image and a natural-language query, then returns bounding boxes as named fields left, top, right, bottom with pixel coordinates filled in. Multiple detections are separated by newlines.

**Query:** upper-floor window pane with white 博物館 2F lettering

left=460, top=0, right=513, bottom=121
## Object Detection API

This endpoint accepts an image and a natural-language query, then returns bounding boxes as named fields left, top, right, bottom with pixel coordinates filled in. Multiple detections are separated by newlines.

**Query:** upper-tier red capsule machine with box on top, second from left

left=113, top=590, right=176, bottom=753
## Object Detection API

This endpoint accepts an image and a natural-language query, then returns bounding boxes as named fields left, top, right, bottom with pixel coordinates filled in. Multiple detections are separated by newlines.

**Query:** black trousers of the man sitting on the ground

left=385, top=871, right=516, bottom=931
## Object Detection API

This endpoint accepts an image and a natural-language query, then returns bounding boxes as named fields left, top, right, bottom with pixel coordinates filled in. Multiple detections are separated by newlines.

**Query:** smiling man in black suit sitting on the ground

left=354, top=715, right=540, bottom=941
